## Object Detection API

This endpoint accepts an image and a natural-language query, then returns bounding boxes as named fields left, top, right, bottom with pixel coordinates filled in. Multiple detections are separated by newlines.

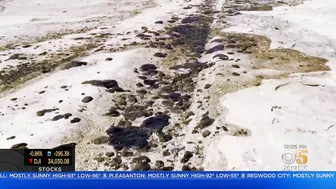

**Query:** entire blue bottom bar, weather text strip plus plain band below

left=0, top=171, right=336, bottom=189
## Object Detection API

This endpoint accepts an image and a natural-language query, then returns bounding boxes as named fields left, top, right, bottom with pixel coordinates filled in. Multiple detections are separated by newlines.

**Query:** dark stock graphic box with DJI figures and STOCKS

left=0, top=149, right=75, bottom=172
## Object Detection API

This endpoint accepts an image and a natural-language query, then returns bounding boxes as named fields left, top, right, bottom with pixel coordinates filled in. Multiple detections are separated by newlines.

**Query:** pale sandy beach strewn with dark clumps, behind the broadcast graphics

left=0, top=0, right=336, bottom=171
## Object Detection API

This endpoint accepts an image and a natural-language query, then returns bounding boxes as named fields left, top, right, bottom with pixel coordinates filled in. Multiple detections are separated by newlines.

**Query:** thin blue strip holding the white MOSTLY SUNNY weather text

left=0, top=171, right=336, bottom=181
